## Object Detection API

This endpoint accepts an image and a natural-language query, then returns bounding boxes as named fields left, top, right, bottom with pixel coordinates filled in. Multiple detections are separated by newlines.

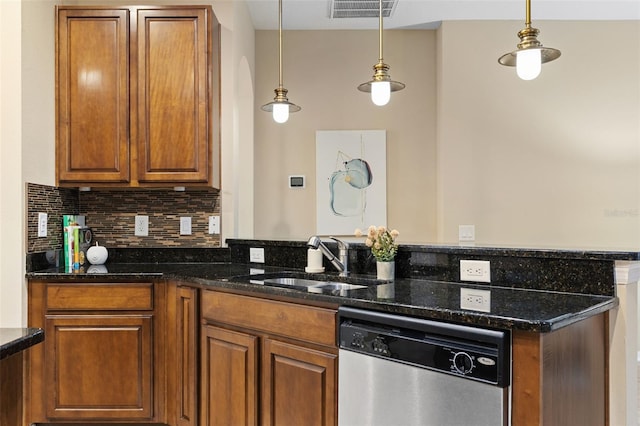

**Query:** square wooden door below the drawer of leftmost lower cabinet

left=44, top=313, right=154, bottom=420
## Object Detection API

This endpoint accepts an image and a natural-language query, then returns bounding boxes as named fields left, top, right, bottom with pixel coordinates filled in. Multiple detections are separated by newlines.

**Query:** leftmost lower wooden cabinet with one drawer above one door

left=25, top=281, right=165, bottom=424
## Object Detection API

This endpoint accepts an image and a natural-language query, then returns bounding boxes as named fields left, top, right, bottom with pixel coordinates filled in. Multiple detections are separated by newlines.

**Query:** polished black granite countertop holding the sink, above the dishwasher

left=27, top=262, right=618, bottom=332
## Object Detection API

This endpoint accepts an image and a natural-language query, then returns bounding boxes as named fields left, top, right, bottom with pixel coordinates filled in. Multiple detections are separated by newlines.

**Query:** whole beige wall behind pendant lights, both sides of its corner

left=255, top=21, right=640, bottom=249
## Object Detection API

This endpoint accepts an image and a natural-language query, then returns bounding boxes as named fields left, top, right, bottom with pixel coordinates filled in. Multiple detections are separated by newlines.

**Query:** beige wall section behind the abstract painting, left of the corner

left=254, top=31, right=436, bottom=241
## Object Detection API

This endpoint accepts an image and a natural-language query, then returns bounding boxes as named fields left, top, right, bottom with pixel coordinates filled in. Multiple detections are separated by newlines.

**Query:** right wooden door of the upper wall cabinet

left=132, top=8, right=214, bottom=183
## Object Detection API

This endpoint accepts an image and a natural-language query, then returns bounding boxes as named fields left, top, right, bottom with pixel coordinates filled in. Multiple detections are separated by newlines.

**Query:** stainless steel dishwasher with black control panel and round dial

left=338, top=307, right=511, bottom=426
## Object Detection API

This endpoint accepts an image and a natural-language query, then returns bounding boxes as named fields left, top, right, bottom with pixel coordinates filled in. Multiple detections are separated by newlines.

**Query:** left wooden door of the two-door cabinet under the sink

left=200, top=325, right=258, bottom=426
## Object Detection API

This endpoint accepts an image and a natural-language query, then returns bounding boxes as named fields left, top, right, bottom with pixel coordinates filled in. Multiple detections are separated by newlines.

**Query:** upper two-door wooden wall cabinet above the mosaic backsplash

left=56, top=6, right=220, bottom=187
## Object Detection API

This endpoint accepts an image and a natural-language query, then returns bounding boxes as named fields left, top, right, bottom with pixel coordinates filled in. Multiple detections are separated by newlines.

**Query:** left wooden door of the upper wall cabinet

left=56, top=8, right=130, bottom=183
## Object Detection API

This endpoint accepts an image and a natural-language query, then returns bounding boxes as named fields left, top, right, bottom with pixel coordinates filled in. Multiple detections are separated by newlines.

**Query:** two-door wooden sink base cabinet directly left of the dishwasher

left=200, top=291, right=338, bottom=426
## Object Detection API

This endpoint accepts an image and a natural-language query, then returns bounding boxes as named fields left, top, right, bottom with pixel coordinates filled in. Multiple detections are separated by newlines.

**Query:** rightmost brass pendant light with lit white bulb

left=498, top=0, right=560, bottom=80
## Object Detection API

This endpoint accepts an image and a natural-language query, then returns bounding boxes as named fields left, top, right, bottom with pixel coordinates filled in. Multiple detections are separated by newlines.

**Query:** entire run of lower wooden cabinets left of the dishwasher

left=25, top=280, right=338, bottom=426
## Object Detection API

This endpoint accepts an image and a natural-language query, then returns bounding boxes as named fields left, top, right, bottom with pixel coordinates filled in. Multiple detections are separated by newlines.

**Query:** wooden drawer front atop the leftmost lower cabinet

left=46, top=283, right=153, bottom=311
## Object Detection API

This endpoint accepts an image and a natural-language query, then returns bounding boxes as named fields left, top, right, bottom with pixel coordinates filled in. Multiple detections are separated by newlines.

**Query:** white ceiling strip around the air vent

left=246, top=0, right=640, bottom=30
